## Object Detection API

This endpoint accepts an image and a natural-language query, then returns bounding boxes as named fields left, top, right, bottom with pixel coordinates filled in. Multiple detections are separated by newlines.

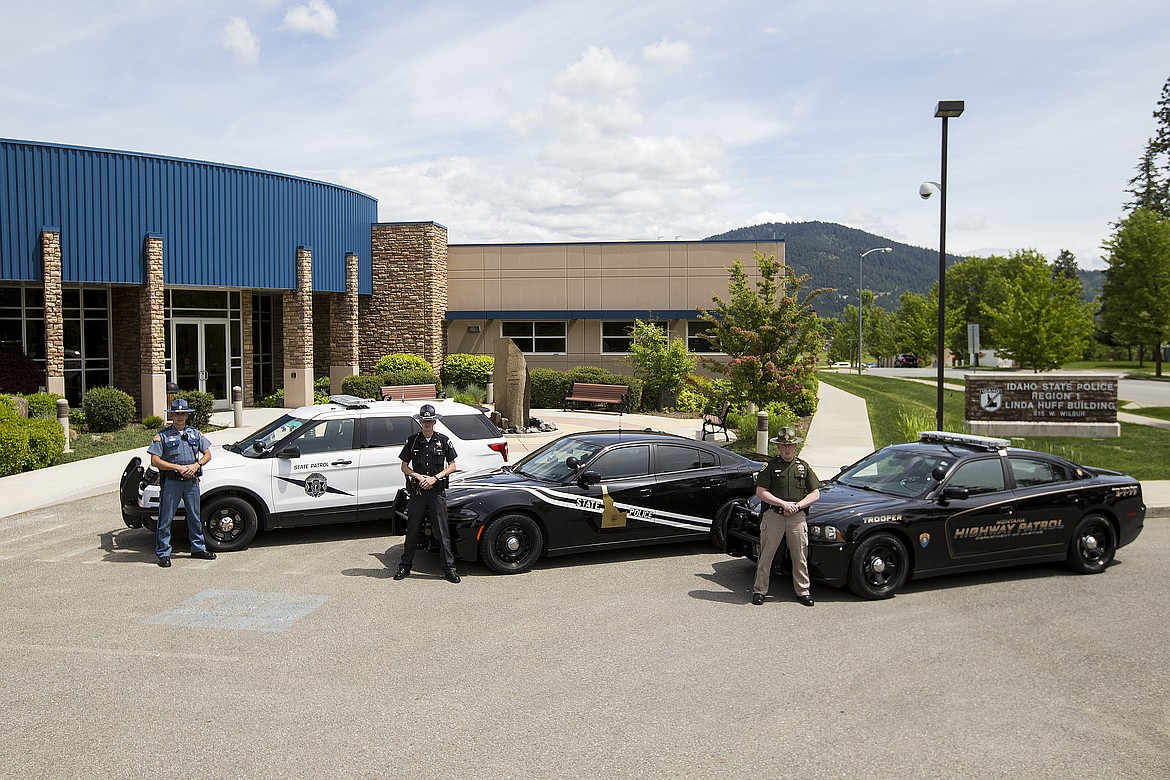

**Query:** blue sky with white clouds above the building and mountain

left=0, top=0, right=1170, bottom=268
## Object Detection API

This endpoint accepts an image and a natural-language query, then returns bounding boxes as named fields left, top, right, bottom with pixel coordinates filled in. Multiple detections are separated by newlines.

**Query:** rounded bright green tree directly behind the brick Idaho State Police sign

left=984, top=257, right=1093, bottom=371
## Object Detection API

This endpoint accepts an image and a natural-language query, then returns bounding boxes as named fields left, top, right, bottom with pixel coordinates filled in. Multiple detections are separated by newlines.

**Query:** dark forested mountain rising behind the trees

left=706, top=222, right=1103, bottom=317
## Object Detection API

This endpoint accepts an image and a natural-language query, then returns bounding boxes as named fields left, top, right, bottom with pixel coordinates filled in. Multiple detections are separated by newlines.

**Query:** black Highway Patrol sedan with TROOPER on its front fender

left=727, top=432, right=1145, bottom=599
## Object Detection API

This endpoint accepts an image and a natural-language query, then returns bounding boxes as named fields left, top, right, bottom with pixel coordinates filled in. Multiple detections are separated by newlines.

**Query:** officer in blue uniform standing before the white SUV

left=146, top=398, right=215, bottom=568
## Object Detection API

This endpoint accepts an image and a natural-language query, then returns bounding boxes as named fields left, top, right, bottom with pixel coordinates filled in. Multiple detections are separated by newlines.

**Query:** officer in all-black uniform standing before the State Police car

left=394, top=403, right=459, bottom=582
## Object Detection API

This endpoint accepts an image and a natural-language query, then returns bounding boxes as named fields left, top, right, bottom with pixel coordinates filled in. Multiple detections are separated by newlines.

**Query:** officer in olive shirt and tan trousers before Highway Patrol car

left=751, top=428, right=820, bottom=607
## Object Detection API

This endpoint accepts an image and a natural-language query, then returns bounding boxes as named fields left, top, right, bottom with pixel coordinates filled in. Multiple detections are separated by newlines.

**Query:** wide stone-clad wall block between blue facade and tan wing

left=359, top=222, right=447, bottom=373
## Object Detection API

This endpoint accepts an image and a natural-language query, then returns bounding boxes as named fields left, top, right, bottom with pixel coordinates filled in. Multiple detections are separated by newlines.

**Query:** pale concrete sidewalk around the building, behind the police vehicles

left=0, top=382, right=1170, bottom=518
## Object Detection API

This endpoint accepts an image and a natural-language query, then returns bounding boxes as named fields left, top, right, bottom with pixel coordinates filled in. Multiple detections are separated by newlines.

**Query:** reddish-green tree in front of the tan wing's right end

left=700, top=251, right=825, bottom=407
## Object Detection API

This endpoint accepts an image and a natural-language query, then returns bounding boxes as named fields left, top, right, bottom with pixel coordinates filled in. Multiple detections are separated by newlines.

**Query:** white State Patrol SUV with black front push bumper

left=121, top=395, right=508, bottom=552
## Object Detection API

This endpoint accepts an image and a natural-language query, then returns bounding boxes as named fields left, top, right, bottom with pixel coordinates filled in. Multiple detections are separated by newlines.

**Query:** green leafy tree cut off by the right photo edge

left=1101, top=208, right=1170, bottom=377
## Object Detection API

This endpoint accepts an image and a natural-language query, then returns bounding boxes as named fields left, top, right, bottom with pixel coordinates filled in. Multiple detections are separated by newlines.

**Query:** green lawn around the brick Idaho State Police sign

left=818, top=372, right=1170, bottom=479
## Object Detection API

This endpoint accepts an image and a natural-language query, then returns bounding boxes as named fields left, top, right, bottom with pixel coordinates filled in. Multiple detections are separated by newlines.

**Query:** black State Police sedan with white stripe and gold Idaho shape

left=395, top=430, right=764, bottom=574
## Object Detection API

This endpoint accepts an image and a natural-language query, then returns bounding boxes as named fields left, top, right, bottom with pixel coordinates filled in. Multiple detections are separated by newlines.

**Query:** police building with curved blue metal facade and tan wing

left=0, top=139, right=784, bottom=415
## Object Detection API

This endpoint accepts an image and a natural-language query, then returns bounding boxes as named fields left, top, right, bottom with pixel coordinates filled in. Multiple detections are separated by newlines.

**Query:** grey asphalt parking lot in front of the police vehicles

left=0, top=495, right=1170, bottom=779
